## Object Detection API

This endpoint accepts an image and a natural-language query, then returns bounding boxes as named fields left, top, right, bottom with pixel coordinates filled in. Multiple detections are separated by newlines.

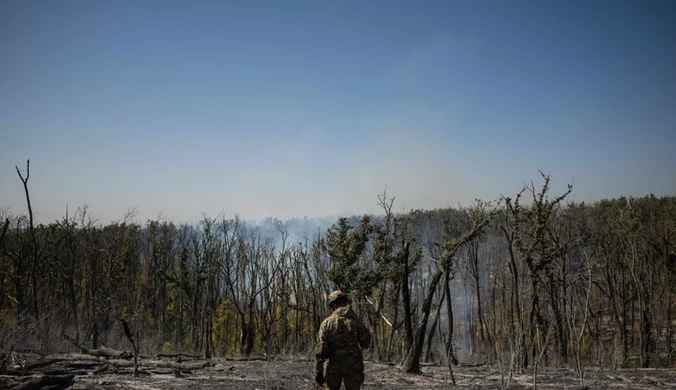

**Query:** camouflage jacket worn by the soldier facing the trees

left=315, top=306, right=371, bottom=367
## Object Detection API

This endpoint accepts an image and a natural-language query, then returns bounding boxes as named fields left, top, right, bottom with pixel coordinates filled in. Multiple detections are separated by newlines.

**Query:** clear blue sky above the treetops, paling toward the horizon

left=0, top=0, right=676, bottom=223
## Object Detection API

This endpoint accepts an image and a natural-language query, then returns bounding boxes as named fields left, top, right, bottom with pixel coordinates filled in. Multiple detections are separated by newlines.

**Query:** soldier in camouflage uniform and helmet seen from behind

left=315, top=290, right=371, bottom=390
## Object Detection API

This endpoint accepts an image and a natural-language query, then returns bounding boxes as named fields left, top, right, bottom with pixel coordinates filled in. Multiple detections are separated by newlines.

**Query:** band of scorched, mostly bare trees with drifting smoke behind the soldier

left=0, top=163, right=676, bottom=378
